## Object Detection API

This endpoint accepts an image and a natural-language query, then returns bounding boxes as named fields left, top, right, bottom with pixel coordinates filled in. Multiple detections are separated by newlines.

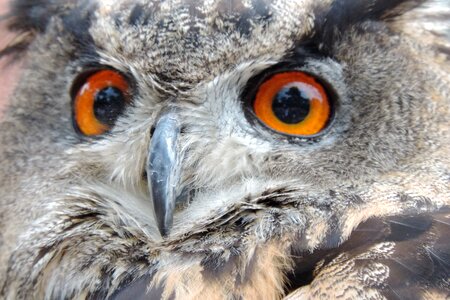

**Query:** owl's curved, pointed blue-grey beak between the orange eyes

left=146, top=112, right=180, bottom=237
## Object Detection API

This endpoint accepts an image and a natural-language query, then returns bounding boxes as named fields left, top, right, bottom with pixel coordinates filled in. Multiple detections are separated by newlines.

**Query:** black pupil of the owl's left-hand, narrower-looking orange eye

left=94, top=86, right=125, bottom=126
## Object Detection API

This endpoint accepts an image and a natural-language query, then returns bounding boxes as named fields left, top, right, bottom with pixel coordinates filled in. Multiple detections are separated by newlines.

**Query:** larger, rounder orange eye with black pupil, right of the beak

left=253, top=71, right=331, bottom=136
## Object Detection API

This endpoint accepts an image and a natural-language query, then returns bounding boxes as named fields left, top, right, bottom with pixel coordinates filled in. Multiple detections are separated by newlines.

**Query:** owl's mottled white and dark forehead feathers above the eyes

left=85, top=0, right=317, bottom=83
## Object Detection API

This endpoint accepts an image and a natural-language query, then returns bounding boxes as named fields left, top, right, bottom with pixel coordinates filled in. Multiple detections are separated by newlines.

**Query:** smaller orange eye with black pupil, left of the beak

left=73, top=70, right=129, bottom=136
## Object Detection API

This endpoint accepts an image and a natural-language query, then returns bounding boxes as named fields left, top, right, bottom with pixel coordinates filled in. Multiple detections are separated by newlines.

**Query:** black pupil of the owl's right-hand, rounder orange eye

left=272, top=84, right=311, bottom=124
